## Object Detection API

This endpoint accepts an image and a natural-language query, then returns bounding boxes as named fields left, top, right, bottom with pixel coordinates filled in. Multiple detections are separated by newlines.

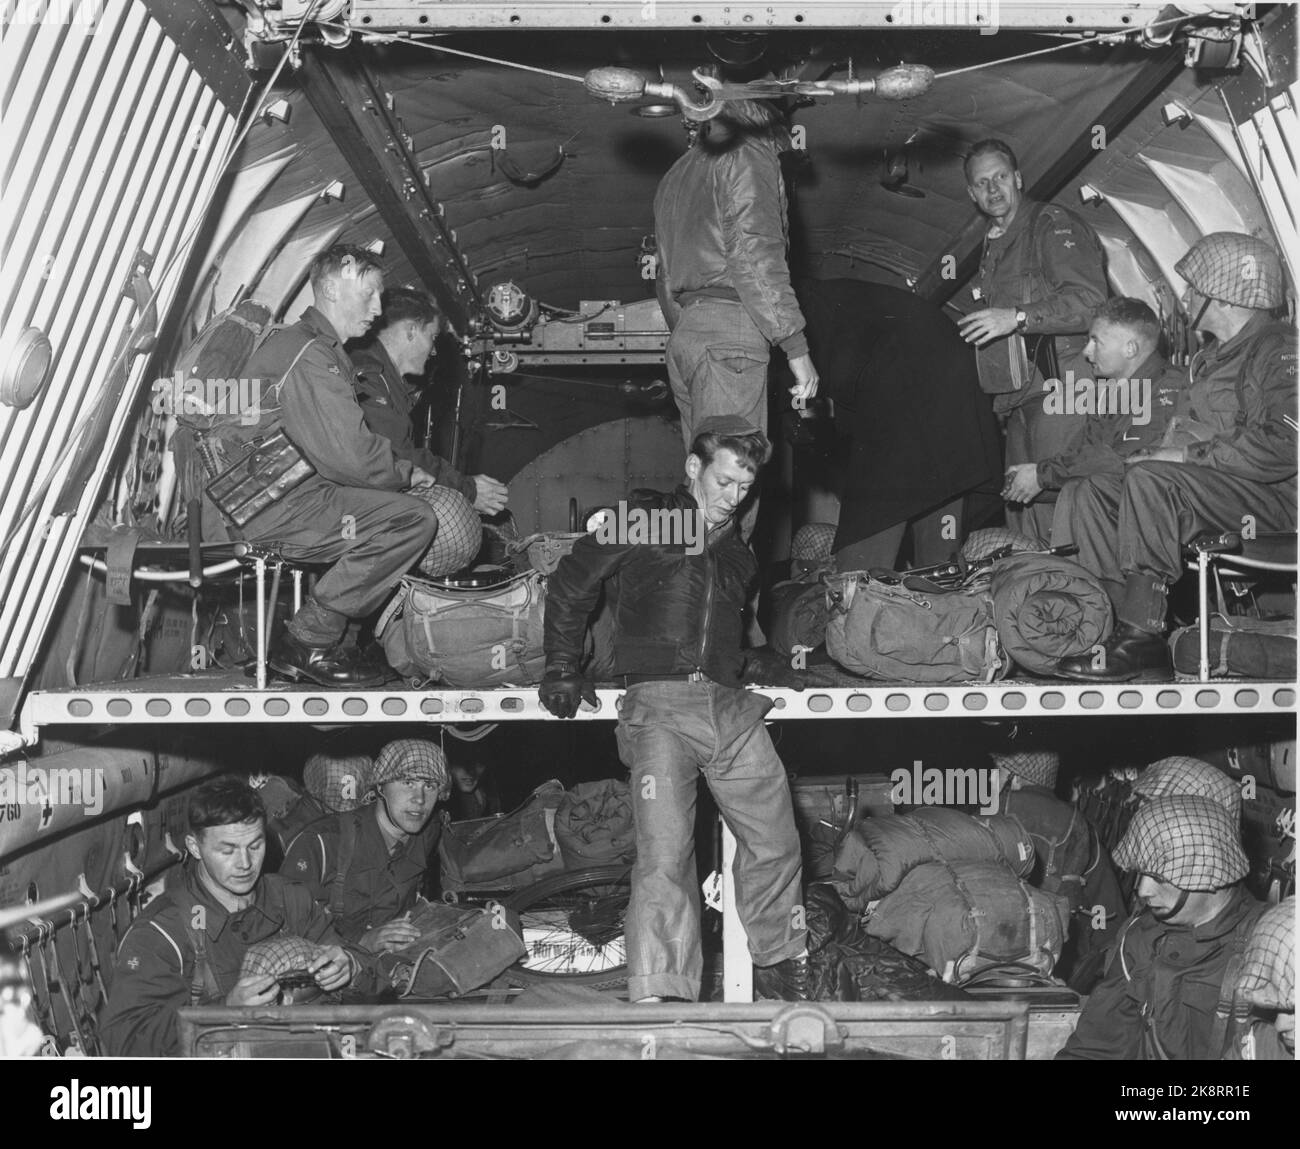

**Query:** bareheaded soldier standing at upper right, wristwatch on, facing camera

left=958, top=139, right=1108, bottom=539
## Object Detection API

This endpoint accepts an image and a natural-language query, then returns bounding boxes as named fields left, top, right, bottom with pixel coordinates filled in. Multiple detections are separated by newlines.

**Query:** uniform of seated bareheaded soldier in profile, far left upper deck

left=204, top=307, right=438, bottom=646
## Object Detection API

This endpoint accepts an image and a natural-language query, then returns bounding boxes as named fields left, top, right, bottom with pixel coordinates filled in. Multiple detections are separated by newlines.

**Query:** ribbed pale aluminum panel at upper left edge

left=0, top=0, right=234, bottom=696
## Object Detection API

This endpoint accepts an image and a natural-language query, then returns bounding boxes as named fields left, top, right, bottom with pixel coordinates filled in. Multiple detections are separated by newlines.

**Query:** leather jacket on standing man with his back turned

left=654, top=135, right=809, bottom=359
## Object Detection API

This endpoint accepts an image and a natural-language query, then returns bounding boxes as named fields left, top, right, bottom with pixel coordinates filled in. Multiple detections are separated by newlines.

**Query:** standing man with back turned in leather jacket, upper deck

left=654, top=100, right=818, bottom=537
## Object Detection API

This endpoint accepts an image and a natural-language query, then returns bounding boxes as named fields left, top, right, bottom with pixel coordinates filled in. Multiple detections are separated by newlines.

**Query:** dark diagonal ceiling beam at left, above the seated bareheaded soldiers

left=298, top=48, right=481, bottom=331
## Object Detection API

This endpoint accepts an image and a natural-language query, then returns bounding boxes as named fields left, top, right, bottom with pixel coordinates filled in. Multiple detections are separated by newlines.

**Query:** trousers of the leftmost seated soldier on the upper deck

left=244, top=480, right=438, bottom=646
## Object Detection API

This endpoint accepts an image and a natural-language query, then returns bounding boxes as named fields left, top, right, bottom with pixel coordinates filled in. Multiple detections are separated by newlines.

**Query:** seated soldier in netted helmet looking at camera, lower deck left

left=280, top=738, right=451, bottom=953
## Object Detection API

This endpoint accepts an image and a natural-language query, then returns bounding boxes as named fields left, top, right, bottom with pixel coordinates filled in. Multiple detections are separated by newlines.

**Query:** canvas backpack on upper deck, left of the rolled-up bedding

left=826, top=571, right=1010, bottom=685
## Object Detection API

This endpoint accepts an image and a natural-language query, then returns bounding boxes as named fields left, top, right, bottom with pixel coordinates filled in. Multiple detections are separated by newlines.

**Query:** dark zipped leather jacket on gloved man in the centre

left=546, top=486, right=758, bottom=686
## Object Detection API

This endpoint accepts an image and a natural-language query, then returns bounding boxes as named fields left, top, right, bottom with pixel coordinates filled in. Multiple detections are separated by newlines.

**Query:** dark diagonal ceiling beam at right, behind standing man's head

left=914, top=47, right=1183, bottom=303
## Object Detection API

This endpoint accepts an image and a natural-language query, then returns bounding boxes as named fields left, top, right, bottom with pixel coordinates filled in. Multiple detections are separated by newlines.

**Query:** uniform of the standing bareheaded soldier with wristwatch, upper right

left=975, top=199, right=1109, bottom=538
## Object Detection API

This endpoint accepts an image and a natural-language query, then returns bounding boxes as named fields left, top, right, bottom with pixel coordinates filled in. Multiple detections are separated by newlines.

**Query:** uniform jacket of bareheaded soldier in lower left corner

left=100, top=866, right=380, bottom=1057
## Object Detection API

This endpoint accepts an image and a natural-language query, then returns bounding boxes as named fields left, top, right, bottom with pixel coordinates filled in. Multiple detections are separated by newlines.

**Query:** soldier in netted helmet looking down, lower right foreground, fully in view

left=1057, top=795, right=1264, bottom=1061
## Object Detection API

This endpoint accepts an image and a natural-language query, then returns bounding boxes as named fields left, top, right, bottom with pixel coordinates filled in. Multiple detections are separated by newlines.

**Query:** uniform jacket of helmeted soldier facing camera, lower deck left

left=280, top=803, right=442, bottom=944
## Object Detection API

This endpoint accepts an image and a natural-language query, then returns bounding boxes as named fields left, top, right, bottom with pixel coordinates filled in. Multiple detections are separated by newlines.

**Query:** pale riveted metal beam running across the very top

left=343, top=0, right=1164, bottom=34
